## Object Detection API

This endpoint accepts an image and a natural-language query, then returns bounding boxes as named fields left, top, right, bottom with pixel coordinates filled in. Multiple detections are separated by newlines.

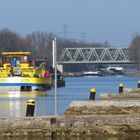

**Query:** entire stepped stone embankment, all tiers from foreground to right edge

left=0, top=85, right=140, bottom=139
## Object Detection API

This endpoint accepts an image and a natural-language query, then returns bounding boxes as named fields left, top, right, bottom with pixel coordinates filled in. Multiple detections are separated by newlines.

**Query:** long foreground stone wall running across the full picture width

left=0, top=115, right=140, bottom=137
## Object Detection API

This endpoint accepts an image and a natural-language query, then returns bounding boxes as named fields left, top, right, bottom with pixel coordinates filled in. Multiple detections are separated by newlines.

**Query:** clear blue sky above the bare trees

left=0, top=0, right=140, bottom=47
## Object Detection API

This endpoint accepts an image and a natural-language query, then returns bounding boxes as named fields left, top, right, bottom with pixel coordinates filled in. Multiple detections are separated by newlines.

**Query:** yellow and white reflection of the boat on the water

left=0, top=91, right=48, bottom=117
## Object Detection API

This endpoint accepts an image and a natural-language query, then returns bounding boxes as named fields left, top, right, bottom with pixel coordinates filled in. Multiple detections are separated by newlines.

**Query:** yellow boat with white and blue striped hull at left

left=0, top=52, right=53, bottom=91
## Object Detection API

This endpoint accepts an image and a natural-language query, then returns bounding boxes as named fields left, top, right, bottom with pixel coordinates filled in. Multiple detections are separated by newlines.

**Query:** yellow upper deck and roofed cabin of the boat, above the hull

left=0, top=52, right=39, bottom=77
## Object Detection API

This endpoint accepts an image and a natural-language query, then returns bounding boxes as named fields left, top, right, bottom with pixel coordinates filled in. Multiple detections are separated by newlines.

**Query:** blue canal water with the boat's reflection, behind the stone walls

left=0, top=76, right=140, bottom=117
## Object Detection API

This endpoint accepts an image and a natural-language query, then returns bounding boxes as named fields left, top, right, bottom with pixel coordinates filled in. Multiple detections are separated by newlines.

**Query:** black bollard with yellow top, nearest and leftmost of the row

left=26, top=99, right=35, bottom=117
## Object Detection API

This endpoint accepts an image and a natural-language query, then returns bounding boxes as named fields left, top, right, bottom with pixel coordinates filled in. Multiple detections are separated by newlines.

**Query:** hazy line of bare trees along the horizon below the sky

left=0, top=28, right=140, bottom=69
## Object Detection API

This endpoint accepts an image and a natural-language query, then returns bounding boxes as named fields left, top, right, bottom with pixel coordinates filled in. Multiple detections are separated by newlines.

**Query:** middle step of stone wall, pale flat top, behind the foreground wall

left=65, top=100, right=140, bottom=115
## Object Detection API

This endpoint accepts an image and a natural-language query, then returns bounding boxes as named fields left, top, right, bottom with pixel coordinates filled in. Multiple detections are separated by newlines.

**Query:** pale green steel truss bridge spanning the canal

left=58, top=48, right=135, bottom=64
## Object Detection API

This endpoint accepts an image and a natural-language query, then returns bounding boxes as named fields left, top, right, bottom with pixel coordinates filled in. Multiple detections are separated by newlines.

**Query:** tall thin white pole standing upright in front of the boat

left=53, top=38, right=57, bottom=116
